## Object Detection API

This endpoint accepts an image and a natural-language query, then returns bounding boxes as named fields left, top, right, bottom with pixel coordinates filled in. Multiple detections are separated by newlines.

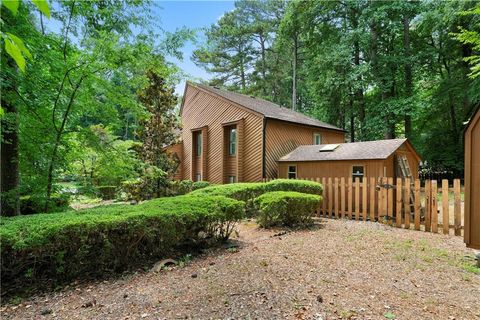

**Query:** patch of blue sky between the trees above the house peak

left=153, top=1, right=234, bottom=94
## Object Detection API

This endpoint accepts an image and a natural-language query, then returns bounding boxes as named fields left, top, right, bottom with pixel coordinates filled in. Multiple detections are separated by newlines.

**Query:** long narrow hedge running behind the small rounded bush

left=190, top=179, right=323, bottom=216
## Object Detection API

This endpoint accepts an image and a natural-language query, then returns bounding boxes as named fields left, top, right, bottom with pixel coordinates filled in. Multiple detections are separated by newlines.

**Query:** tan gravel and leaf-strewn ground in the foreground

left=1, top=220, right=480, bottom=320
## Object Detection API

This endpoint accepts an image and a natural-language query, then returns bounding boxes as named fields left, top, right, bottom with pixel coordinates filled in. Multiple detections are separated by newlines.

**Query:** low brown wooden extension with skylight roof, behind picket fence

left=278, top=139, right=420, bottom=179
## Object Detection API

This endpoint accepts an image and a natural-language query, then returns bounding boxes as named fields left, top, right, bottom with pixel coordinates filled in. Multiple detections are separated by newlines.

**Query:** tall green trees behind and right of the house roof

left=194, top=0, right=480, bottom=176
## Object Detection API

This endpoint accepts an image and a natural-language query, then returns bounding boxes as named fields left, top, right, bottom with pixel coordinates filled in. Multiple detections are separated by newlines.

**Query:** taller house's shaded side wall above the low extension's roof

left=265, top=119, right=345, bottom=179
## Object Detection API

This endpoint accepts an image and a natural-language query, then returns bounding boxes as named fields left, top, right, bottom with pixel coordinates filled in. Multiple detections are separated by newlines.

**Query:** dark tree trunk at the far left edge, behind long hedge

left=0, top=98, right=20, bottom=216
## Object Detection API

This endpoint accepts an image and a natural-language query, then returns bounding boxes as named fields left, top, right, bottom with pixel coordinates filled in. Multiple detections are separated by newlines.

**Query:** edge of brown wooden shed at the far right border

left=464, top=108, right=480, bottom=250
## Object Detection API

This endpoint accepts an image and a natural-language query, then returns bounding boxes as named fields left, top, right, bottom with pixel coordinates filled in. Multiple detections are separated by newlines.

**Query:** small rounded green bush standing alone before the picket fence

left=254, top=191, right=321, bottom=228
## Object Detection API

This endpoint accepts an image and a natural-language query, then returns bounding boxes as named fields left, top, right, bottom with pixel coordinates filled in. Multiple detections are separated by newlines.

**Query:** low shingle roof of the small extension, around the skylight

left=279, top=139, right=407, bottom=161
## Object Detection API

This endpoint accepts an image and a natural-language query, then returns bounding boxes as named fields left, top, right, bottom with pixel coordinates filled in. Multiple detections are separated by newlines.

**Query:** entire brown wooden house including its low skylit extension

left=167, top=82, right=420, bottom=184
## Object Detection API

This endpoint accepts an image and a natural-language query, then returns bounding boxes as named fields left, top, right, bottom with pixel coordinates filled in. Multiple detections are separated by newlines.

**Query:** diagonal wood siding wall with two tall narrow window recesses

left=182, top=85, right=263, bottom=183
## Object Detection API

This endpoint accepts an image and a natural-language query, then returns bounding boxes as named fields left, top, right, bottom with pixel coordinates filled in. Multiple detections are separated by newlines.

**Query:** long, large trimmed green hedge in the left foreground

left=0, top=195, right=244, bottom=292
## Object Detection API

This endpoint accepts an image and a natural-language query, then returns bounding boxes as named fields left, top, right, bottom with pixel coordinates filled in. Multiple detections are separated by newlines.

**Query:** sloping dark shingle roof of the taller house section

left=193, top=84, right=345, bottom=131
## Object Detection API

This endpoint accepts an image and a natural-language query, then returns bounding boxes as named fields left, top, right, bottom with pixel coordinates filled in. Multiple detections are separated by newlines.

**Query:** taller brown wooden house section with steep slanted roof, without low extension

left=167, top=82, right=345, bottom=183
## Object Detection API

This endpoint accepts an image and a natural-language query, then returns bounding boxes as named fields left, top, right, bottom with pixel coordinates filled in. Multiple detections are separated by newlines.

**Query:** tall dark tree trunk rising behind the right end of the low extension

left=403, top=16, right=413, bottom=138
